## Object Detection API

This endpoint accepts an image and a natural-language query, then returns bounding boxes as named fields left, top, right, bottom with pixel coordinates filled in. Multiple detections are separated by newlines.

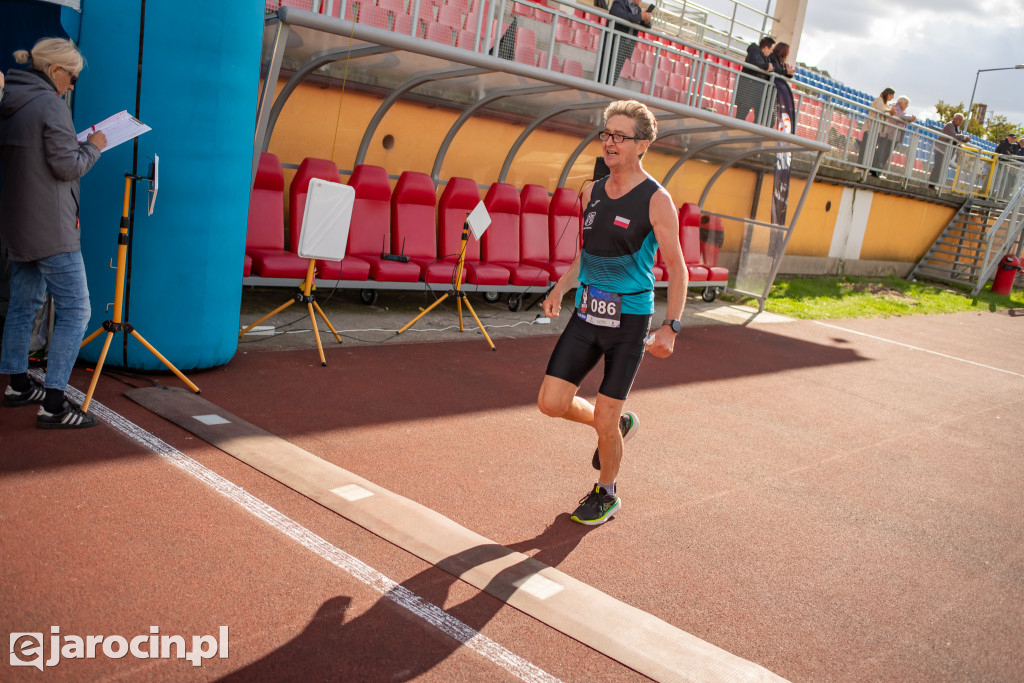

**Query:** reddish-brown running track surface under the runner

left=0, top=312, right=1024, bottom=681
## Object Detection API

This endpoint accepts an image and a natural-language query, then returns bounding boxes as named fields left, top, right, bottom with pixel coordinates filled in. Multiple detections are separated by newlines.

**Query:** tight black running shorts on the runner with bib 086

left=547, top=310, right=651, bottom=400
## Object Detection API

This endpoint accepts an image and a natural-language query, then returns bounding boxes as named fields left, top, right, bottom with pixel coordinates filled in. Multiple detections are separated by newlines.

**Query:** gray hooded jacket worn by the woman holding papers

left=0, top=70, right=99, bottom=261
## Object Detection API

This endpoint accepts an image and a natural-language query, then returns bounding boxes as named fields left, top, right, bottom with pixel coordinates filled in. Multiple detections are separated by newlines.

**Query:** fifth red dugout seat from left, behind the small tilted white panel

left=437, top=177, right=509, bottom=285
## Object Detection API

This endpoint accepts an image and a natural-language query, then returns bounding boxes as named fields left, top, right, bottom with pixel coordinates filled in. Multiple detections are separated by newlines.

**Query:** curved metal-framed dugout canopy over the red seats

left=252, top=8, right=830, bottom=308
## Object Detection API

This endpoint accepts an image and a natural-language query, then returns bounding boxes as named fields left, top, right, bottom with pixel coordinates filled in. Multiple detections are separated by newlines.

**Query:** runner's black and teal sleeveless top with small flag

left=577, top=177, right=662, bottom=315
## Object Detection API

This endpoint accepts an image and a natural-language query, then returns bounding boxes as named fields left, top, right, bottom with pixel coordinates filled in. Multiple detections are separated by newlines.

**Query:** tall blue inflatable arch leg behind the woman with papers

left=74, top=0, right=264, bottom=371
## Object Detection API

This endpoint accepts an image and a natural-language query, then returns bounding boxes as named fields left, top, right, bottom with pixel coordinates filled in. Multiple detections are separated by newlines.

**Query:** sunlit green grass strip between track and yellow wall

left=740, top=275, right=1024, bottom=319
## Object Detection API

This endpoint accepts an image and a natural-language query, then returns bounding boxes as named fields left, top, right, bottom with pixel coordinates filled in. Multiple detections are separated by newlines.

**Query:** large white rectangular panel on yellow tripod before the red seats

left=298, top=178, right=355, bottom=261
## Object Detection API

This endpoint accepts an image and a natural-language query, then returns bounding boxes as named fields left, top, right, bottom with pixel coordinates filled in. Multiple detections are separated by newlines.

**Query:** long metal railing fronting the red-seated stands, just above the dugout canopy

left=267, top=0, right=1021, bottom=202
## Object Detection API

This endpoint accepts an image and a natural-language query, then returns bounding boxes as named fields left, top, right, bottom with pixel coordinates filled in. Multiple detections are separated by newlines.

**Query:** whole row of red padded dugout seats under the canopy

left=243, top=154, right=729, bottom=288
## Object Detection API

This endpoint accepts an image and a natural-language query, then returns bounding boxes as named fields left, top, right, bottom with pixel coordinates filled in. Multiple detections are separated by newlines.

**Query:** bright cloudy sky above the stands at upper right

left=797, top=0, right=1024, bottom=126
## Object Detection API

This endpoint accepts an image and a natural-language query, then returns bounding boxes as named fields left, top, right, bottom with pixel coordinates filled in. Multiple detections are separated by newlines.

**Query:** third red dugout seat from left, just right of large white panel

left=346, top=164, right=421, bottom=283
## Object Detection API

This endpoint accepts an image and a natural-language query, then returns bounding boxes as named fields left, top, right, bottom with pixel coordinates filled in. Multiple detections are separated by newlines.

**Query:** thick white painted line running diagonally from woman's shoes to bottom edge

left=48, top=378, right=559, bottom=683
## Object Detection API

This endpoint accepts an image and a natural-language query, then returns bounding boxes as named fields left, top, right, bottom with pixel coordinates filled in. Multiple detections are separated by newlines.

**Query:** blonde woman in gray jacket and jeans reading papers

left=0, top=38, right=106, bottom=429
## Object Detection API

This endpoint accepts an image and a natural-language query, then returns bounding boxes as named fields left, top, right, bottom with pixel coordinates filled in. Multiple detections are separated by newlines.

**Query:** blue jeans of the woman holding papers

left=0, top=251, right=90, bottom=390
